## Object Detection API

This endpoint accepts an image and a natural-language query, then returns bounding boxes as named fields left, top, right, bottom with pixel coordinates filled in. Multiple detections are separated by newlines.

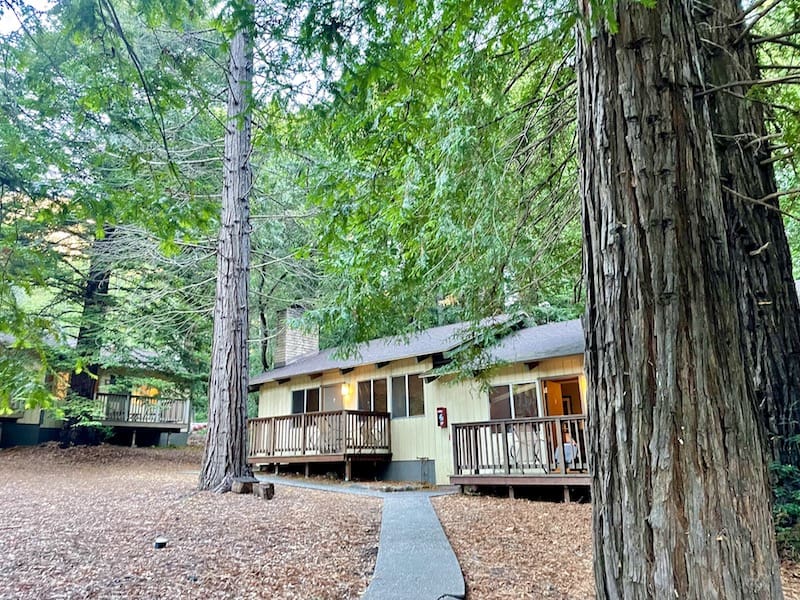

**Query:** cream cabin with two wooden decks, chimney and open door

left=248, top=309, right=589, bottom=493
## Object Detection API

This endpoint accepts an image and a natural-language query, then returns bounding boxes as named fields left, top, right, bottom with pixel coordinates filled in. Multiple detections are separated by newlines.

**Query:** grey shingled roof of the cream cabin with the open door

left=250, top=319, right=583, bottom=388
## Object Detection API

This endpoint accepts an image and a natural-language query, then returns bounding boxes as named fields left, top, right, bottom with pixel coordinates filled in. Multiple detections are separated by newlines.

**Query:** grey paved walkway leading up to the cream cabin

left=258, top=475, right=466, bottom=600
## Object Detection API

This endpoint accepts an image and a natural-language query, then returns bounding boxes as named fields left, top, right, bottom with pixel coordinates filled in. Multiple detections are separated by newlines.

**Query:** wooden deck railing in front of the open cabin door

left=453, top=415, right=589, bottom=476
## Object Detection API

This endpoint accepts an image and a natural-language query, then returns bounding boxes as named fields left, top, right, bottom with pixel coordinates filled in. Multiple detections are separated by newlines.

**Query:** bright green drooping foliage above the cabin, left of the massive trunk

left=274, top=2, right=580, bottom=342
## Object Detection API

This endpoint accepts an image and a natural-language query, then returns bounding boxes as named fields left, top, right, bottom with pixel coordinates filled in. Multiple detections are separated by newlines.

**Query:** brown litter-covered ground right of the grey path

left=433, top=496, right=800, bottom=600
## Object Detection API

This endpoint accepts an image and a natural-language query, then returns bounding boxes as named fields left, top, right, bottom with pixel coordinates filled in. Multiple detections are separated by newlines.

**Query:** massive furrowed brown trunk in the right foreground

left=578, top=0, right=782, bottom=600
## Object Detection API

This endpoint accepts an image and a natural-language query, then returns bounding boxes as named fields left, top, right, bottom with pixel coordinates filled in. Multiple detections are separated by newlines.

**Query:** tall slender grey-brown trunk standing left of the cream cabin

left=199, top=17, right=253, bottom=490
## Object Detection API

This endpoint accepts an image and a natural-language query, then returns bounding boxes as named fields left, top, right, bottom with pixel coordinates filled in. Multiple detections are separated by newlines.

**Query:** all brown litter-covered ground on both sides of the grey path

left=0, top=444, right=800, bottom=600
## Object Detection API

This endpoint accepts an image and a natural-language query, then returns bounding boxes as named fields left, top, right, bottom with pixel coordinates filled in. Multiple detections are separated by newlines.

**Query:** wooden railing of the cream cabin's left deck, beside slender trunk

left=247, top=410, right=391, bottom=459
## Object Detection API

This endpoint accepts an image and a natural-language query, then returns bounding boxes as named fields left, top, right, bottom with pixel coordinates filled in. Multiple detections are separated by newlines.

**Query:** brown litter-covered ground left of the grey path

left=0, top=445, right=381, bottom=600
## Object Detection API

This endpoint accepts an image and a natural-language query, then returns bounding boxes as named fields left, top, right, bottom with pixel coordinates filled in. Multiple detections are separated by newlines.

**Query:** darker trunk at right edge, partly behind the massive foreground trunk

left=696, top=0, right=800, bottom=466
